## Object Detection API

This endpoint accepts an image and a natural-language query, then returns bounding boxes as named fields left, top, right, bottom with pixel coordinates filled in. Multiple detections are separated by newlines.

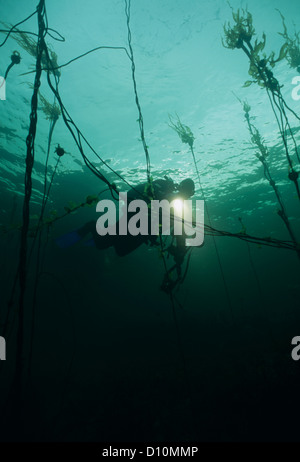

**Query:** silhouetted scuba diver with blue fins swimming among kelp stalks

left=56, top=177, right=195, bottom=258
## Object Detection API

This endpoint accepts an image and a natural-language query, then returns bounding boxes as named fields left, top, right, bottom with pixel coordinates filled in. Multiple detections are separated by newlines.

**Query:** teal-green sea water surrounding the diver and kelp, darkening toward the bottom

left=0, top=0, right=300, bottom=442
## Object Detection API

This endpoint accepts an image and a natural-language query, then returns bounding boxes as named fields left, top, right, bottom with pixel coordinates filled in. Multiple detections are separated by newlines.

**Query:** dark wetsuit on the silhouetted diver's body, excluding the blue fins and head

left=77, top=179, right=175, bottom=256
